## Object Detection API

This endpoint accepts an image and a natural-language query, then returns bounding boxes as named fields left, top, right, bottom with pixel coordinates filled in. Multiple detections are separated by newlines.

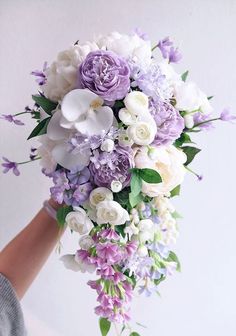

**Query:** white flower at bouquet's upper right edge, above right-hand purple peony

left=174, top=81, right=212, bottom=114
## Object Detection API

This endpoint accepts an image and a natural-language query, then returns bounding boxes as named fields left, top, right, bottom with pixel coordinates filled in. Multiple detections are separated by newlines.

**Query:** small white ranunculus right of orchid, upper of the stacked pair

left=124, top=91, right=148, bottom=116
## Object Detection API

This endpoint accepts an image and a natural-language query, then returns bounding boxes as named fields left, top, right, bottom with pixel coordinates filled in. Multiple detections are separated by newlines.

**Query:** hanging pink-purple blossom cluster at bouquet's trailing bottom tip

left=75, top=228, right=137, bottom=323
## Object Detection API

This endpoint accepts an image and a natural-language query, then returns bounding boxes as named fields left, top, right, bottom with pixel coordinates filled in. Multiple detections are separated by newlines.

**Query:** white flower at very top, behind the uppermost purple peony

left=96, top=32, right=152, bottom=66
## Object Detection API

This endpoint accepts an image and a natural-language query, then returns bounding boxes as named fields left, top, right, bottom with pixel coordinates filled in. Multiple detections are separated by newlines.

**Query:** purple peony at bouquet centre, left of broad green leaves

left=89, top=146, right=133, bottom=188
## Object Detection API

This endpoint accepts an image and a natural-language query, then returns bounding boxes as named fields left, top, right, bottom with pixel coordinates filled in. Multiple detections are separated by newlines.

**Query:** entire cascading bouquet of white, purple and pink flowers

left=2, top=30, right=235, bottom=336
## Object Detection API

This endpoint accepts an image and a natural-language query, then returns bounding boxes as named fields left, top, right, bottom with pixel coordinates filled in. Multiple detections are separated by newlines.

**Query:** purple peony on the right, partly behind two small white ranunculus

left=151, top=102, right=184, bottom=146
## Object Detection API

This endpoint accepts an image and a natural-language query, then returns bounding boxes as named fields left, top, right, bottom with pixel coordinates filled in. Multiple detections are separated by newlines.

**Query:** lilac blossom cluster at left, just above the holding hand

left=50, top=167, right=93, bottom=206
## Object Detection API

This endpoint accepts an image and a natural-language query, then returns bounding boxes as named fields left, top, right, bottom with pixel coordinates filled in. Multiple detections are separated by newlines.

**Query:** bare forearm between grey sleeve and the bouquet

left=0, top=199, right=64, bottom=299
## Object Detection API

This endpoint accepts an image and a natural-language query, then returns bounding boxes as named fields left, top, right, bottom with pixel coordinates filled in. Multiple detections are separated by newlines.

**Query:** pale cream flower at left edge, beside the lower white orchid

left=38, top=134, right=57, bottom=174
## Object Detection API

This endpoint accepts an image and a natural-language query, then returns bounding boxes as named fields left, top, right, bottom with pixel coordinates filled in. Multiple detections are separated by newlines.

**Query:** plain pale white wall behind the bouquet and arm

left=0, top=0, right=236, bottom=336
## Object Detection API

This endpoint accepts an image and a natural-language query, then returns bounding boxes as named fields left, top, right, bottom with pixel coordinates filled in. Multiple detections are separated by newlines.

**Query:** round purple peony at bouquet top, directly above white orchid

left=79, top=50, right=130, bottom=102
